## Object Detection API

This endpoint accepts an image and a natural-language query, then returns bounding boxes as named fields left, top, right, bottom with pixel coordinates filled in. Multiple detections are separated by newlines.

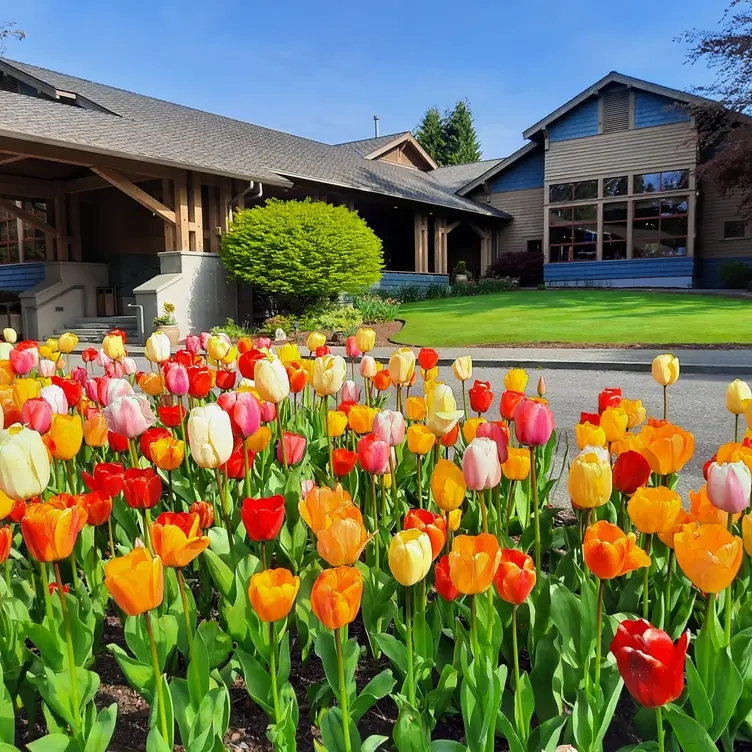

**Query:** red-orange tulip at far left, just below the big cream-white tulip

left=21, top=494, right=87, bottom=562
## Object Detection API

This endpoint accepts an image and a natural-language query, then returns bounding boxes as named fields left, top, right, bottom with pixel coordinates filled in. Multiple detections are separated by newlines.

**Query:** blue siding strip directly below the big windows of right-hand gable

left=543, top=256, right=694, bottom=282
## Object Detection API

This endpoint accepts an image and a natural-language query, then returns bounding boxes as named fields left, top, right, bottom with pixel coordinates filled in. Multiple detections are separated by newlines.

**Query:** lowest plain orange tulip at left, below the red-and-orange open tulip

left=104, top=546, right=164, bottom=616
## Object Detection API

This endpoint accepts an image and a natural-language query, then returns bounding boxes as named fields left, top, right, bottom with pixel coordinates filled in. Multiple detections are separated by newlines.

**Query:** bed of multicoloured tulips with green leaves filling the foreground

left=0, top=329, right=752, bottom=752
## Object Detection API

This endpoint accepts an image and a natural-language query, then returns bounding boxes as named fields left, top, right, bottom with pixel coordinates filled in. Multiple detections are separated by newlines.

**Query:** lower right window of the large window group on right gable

left=632, top=196, right=689, bottom=258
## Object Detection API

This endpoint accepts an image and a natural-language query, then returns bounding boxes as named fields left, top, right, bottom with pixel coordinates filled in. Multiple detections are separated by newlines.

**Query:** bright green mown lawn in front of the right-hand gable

left=394, top=289, right=752, bottom=347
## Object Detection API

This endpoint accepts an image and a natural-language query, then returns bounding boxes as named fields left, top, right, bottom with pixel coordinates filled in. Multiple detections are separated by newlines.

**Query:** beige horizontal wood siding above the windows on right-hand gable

left=546, top=123, right=697, bottom=183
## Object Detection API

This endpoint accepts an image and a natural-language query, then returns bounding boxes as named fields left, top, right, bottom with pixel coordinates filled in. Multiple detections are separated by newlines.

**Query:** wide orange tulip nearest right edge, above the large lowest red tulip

left=674, top=524, right=744, bottom=593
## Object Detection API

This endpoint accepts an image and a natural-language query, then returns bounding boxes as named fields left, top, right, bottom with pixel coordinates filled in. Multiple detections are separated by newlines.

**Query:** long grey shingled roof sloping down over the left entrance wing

left=0, top=59, right=509, bottom=218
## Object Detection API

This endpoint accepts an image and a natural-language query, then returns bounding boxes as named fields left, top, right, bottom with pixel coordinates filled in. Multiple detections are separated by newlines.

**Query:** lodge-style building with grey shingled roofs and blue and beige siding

left=0, top=59, right=752, bottom=339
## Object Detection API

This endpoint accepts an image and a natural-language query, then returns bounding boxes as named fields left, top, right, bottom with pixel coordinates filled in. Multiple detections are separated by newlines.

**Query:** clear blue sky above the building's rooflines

left=0, top=0, right=728, bottom=158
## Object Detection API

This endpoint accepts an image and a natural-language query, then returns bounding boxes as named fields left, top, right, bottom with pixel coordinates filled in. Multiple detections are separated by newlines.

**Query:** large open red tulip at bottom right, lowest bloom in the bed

left=611, top=619, right=689, bottom=708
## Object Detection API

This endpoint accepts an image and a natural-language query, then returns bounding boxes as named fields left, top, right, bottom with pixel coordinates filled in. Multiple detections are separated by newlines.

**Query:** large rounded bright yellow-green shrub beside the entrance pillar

left=217, top=199, right=383, bottom=312
